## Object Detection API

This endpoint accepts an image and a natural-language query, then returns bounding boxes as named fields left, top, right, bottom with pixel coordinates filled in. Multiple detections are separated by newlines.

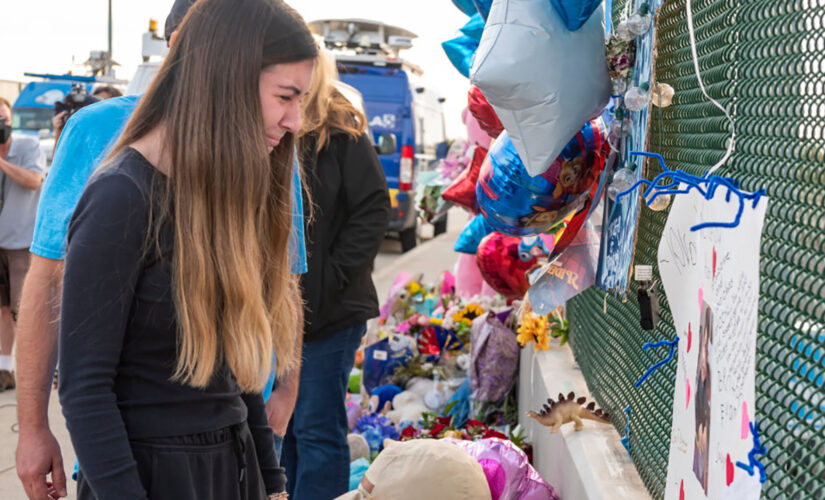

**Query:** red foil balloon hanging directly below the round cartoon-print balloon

left=476, top=233, right=536, bottom=299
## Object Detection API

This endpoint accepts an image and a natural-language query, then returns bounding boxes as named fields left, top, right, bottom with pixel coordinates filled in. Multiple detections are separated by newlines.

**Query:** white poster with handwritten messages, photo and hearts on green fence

left=658, top=189, right=768, bottom=500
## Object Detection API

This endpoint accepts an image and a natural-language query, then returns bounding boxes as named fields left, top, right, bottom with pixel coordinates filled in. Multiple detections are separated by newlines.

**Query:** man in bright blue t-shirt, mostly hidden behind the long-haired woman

left=17, top=0, right=306, bottom=498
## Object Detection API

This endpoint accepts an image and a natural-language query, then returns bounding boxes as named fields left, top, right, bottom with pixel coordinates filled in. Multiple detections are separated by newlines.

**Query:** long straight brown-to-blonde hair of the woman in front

left=105, top=0, right=317, bottom=392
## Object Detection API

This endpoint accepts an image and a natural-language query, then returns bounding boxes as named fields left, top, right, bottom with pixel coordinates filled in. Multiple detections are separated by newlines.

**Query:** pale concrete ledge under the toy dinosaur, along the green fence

left=518, top=341, right=650, bottom=500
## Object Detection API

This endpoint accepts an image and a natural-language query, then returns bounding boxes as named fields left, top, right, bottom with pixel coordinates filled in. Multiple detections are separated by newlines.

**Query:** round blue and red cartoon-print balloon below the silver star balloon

left=476, top=118, right=607, bottom=236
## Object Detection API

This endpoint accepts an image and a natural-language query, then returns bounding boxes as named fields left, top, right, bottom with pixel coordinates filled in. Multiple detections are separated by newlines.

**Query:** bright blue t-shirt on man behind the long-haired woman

left=30, top=96, right=307, bottom=274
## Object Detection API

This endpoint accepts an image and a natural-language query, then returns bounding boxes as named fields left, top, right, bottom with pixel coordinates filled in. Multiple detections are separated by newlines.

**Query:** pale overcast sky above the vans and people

left=0, top=0, right=469, bottom=137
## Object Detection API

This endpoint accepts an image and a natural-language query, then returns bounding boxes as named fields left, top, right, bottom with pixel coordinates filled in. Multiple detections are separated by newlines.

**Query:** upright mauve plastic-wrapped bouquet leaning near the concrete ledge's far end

left=470, top=314, right=520, bottom=402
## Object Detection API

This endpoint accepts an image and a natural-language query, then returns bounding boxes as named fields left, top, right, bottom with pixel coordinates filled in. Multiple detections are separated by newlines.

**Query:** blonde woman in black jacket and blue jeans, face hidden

left=273, top=47, right=390, bottom=500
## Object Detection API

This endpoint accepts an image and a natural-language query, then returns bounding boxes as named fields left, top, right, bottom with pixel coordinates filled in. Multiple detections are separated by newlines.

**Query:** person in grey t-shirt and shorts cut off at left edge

left=0, top=97, right=45, bottom=392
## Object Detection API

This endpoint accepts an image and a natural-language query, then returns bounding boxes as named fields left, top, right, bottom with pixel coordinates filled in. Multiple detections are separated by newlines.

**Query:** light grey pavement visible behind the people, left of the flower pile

left=0, top=209, right=468, bottom=500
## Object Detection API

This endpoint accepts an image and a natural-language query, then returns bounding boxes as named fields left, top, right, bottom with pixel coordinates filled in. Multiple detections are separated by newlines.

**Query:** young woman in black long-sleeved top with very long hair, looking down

left=59, top=0, right=317, bottom=500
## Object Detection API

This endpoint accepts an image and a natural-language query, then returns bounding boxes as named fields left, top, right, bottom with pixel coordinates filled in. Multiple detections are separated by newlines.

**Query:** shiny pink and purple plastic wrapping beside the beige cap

left=445, top=438, right=559, bottom=500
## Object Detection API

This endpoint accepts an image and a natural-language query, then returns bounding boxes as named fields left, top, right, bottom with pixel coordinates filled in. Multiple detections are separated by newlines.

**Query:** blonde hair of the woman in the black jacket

left=298, top=49, right=367, bottom=153
